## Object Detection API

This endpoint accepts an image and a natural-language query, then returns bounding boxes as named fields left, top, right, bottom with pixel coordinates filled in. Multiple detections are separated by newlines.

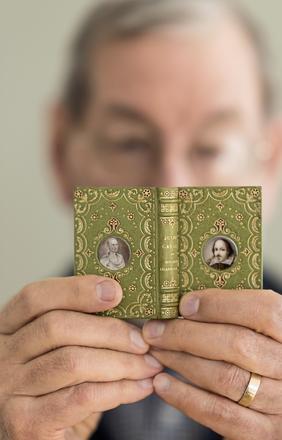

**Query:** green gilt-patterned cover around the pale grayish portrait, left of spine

left=74, top=188, right=160, bottom=318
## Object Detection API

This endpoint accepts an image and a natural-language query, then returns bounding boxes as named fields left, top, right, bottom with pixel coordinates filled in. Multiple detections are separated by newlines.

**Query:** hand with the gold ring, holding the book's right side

left=143, top=289, right=282, bottom=440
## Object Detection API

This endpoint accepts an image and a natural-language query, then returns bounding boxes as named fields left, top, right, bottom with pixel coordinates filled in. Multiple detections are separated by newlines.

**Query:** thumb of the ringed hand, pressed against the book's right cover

left=180, top=289, right=282, bottom=342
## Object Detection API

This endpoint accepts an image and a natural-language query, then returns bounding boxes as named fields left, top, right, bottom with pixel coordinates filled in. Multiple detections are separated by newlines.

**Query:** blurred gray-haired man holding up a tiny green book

left=0, top=0, right=282, bottom=440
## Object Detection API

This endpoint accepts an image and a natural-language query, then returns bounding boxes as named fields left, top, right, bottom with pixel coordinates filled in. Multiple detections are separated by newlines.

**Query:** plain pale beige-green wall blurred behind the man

left=0, top=0, right=282, bottom=303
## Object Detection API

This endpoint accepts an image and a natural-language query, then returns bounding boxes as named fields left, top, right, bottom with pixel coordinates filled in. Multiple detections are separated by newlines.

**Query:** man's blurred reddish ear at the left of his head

left=48, top=103, right=73, bottom=204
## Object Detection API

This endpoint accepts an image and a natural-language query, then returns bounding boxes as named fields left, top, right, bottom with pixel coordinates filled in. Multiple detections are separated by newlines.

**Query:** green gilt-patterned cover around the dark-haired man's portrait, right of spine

left=179, top=187, right=262, bottom=294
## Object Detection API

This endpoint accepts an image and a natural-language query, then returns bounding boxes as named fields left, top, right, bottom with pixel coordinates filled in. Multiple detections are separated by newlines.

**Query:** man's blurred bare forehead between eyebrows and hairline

left=91, top=19, right=261, bottom=131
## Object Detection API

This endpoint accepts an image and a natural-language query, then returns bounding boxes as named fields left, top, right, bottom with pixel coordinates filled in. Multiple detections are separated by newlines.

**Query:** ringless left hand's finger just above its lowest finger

left=13, top=347, right=162, bottom=396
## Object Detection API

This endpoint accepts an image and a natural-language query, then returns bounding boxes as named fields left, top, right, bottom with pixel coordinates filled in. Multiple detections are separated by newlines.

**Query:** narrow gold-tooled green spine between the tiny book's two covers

left=157, top=188, right=179, bottom=319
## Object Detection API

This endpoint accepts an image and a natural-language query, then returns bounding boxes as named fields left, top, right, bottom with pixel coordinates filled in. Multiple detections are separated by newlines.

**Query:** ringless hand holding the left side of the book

left=0, top=275, right=162, bottom=440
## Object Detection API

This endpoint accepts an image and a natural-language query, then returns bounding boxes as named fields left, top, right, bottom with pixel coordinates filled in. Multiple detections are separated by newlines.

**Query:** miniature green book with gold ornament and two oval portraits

left=74, top=187, right=262, bottom=319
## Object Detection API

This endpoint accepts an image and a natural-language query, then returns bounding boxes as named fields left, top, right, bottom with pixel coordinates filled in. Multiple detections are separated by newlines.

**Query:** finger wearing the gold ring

left=151, top=350, right=282, bottom=415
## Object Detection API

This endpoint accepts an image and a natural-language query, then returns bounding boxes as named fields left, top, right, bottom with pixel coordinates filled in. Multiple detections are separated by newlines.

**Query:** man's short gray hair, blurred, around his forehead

left=63, top=0, right=276, bottom=122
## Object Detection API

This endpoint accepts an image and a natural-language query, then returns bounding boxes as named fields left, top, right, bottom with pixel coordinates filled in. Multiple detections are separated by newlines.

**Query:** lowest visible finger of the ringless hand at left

left=6, top=379, right=153, bottom=439
